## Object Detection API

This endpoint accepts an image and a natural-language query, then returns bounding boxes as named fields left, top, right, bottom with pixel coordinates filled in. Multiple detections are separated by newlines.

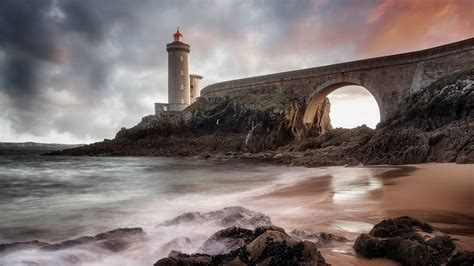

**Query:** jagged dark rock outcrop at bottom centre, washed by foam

left=155, top=226, right=328, bottom=266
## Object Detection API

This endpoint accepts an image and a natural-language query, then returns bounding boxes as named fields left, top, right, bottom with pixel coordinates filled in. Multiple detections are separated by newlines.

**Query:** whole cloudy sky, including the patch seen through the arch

left=0, top=0, right=474, bottom=143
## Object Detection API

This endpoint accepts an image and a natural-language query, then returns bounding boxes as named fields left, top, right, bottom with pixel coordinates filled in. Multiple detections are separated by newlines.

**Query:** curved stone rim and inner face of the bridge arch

left=303, top=80, right=385, bottom=124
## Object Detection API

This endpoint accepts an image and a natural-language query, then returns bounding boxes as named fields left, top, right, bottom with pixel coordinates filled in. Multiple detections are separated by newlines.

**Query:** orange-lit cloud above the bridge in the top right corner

left=359, top=0, right=474, bottom=56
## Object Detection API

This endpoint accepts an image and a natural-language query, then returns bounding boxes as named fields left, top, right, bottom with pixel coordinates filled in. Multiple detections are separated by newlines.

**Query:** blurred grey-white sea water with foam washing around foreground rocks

left=0, top=155, right=318, bottom=265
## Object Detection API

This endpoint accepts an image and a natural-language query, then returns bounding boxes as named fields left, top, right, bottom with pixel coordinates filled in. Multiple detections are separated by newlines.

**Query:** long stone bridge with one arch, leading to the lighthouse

left=201, top=38, right=474, bottom=124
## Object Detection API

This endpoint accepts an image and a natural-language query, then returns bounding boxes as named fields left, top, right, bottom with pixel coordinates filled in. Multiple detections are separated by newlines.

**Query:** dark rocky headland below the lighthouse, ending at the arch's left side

left=52, top=88, right=331, bottom=156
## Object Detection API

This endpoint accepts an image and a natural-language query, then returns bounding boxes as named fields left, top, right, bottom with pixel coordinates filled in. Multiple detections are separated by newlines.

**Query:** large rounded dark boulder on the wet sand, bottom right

left=354, top=216, right=455, bottom=265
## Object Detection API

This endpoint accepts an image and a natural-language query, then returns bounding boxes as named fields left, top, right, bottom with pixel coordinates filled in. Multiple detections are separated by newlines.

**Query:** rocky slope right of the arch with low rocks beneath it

left=254, top=69, right=474, bottom=166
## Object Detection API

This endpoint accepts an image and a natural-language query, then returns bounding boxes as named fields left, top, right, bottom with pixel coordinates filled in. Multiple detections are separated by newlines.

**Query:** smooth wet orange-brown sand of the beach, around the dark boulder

left=246, top=164, right=474, bottom=265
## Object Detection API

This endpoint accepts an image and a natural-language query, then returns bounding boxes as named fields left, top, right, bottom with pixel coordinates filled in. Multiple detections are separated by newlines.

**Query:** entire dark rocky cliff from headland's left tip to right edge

left=52, top=69, right=474, bottom=166
